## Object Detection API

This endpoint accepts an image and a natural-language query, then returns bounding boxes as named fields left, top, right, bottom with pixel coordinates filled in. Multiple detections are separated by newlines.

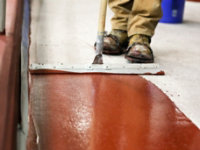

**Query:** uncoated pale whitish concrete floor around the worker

left=30, top=0, right=200, bottom=128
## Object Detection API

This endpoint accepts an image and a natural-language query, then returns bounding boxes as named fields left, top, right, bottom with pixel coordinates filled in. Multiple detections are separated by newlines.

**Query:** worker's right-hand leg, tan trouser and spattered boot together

left=125, top=0, right=162, bottom=63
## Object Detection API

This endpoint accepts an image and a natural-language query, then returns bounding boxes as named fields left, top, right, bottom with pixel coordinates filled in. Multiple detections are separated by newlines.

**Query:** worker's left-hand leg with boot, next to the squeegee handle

left=97, top=0, right=133, bottom=54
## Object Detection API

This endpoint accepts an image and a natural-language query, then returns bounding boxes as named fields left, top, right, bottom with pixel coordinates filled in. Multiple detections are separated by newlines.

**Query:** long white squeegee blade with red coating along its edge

left=29, top=63, right=164, bottom=75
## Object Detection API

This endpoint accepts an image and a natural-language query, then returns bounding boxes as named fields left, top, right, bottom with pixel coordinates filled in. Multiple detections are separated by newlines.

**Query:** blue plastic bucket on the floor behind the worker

left=160, top=0, right=185, bottom=23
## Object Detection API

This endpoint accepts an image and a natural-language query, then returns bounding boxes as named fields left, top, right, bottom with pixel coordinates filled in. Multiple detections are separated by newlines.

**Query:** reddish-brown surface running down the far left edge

left=0, top=0, right=23, bottom=150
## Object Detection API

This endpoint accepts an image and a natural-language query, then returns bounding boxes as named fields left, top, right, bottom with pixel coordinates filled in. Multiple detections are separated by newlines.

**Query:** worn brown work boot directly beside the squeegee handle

left=95, top=30, right=128, bottom=55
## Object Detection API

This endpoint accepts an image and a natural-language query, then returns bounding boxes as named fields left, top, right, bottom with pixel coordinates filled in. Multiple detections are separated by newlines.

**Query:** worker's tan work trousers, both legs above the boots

left=109, top=0, right=162, bottom=37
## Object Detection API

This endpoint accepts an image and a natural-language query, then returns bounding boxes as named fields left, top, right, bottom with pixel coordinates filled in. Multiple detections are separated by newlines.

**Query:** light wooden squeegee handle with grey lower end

left=96, top=0, right=107, bottom=55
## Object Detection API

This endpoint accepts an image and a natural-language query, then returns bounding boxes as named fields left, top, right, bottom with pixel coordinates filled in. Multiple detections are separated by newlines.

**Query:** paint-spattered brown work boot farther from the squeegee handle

left=125, top=34, right=154, bottom=63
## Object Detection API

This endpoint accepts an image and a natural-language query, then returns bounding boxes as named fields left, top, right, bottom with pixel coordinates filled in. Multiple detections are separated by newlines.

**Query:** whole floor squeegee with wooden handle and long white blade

left=29, top=0, right=164, bottom=75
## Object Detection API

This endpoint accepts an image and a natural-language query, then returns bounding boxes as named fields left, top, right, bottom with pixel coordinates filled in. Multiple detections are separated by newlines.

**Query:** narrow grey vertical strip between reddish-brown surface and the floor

left=17, top=0, right=30, bottom=150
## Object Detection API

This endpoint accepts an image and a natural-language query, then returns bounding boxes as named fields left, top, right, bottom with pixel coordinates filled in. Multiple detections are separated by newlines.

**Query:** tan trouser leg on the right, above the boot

left=127, top=0, right=162, bottom=37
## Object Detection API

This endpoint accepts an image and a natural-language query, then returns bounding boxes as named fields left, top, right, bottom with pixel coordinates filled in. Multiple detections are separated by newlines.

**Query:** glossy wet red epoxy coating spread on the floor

left=27, top=74, right=200, bottom=150
